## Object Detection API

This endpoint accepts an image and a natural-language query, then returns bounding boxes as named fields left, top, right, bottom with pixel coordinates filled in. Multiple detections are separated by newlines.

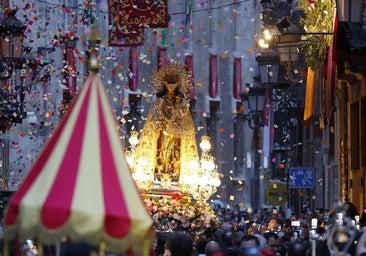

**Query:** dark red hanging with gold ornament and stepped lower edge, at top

left=108, top=0, right=168, bottom=46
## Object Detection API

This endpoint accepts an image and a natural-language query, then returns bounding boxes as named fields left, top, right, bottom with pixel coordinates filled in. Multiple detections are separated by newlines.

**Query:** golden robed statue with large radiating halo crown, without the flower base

left=132, top=63, right=199, bottom=192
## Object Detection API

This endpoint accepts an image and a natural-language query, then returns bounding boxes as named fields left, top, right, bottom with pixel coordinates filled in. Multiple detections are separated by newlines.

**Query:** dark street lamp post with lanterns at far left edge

left=0, top=9, right=29, bottom=190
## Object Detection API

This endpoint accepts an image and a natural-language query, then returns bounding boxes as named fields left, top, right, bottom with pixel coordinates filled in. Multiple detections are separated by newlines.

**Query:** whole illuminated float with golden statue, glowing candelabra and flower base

left=126, top=62, right=220, bottom=234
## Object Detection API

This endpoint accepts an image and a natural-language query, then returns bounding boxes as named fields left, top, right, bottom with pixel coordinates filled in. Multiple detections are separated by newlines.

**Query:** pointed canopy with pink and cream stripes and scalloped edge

left=4, top=74, right=152, bottom=253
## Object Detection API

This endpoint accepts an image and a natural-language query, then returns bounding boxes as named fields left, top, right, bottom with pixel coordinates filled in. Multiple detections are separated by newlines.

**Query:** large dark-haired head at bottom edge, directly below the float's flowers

left=164, top=231, right=194, bottom=256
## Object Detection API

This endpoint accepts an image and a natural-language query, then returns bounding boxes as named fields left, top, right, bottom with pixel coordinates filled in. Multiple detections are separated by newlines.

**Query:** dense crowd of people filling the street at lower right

left=152, top=203, right=366, bottom=256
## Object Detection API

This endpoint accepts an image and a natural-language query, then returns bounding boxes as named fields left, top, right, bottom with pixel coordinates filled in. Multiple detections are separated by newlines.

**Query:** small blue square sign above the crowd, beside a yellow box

left=290, top=167, right=315, bottom=188
